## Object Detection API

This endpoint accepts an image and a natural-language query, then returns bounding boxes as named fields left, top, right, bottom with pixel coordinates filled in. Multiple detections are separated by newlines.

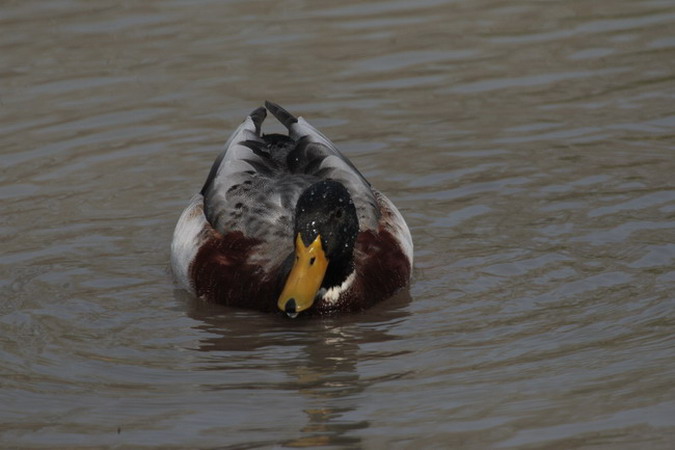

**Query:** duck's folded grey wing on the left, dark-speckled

left=201, top=107, right=302, bottom=242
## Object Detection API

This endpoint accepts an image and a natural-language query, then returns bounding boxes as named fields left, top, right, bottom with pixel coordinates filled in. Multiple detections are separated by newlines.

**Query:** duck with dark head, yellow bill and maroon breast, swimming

left=171, top=101, right=413, bottom=318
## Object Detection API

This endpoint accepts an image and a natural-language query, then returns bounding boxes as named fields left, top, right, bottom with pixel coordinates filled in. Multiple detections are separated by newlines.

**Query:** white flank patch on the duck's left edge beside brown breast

left=171, top=194, right=208, bottom=293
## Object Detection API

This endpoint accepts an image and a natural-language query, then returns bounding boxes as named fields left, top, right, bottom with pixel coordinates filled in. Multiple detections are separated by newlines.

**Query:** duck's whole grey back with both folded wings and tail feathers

left=201, top=102, right=380, bottom=263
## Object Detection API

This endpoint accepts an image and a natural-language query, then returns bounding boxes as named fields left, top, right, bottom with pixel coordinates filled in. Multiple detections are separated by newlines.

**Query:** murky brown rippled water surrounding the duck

left=0, top=0, right=675, bottom=448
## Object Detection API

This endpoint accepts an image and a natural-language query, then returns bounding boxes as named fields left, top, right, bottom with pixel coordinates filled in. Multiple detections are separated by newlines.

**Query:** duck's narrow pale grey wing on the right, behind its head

left=265, top=101, right=380, bottom=230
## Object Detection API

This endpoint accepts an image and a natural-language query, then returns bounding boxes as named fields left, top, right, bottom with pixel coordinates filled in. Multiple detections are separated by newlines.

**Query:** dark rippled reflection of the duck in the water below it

left=181, top=290, right=413, bottom=448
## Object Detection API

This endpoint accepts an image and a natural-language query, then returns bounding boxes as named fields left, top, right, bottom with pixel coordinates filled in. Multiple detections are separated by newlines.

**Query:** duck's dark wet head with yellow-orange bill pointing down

left=277, top=180, right=359, bottom=317
